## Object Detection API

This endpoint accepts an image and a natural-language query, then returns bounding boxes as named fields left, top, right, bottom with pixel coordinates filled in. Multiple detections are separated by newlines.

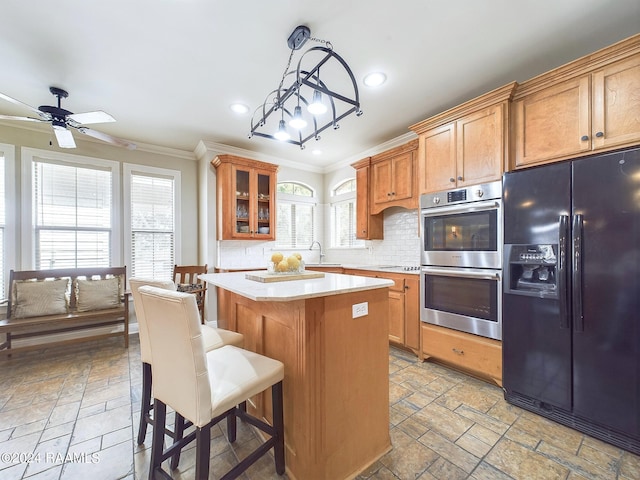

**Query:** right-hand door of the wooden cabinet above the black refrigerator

left=592, top=55, right=640, bottom=148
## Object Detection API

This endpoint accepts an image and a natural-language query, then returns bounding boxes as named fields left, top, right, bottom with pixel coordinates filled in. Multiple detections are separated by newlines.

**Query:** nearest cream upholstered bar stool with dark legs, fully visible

left=138, top=286, right=285, bottom=479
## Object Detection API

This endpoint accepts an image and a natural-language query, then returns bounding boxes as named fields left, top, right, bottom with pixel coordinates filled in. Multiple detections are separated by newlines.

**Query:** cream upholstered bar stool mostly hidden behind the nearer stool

left=129, top=277, right=244, bottom=448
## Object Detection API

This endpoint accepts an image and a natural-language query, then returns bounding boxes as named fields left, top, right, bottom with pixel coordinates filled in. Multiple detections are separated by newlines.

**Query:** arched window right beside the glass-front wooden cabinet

left=276, top=182, right=316, bottom=248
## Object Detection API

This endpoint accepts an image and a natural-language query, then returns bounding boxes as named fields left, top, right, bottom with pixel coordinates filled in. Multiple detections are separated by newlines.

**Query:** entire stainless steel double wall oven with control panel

left=420, top=181, right=502, bottom=340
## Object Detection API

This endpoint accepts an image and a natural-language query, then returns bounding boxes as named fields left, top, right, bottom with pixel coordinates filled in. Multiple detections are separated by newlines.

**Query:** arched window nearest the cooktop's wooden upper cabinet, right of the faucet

left=331, top=178, right=364, bottom=248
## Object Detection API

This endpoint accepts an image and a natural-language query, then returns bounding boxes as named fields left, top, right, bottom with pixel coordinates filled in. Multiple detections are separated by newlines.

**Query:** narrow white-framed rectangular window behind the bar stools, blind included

left=124, top=165, right=180, bottom=280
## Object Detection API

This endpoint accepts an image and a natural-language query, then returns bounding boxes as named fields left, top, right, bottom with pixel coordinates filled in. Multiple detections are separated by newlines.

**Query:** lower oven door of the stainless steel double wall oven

left=420, top=267, right=502, bottom=340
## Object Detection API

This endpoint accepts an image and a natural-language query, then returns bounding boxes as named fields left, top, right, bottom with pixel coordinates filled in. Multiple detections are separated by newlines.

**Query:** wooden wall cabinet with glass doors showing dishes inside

left=211, top=155, right=278, bottom=240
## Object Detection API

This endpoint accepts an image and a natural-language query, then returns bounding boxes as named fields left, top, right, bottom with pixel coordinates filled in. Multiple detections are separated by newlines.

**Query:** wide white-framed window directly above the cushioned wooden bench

left=22, top=148, right=121, bottom=270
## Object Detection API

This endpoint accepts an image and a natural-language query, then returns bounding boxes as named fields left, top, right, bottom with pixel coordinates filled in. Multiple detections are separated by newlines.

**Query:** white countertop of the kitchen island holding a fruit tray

left=199, top=270, right=393, bottom=302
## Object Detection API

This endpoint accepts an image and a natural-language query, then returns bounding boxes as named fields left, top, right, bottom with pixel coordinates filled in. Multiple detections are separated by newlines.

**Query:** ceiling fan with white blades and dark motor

left=0, top=87, right=136, bottom=150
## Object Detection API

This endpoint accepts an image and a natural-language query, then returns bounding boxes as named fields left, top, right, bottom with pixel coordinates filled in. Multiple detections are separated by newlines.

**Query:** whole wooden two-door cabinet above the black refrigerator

left=512, top=35, right=640, bottom=168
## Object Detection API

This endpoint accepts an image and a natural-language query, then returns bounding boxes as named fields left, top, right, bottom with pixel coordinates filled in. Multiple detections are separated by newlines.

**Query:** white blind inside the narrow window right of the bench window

left=131, top=172, right=176, bottom=280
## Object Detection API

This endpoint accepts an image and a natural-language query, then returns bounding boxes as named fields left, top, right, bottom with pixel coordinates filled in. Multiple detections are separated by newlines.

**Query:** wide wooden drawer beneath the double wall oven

left=422, top=324, right=502, bottom=386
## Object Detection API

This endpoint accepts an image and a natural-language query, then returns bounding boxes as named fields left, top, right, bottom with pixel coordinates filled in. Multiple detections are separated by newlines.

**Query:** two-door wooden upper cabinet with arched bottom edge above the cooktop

left=371, top=140, right=419, bottom=214
